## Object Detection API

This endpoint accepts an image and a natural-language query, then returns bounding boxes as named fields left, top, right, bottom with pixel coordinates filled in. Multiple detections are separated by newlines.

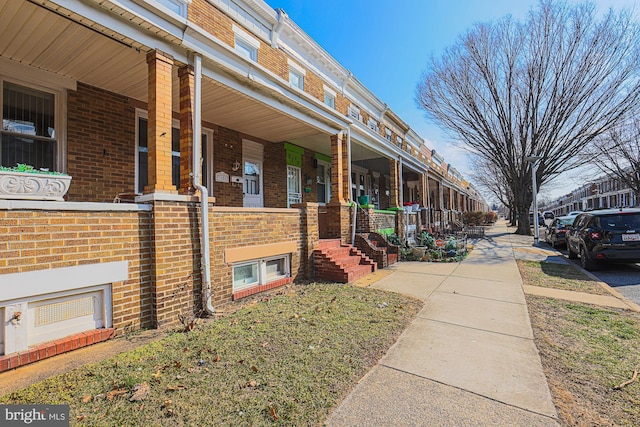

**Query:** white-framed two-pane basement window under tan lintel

left=233, top=255, right=291, bottom=292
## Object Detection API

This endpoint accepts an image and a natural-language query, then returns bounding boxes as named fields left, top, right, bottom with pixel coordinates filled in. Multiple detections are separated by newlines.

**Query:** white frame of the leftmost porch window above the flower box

left=0, top=75, right=67, bottom=172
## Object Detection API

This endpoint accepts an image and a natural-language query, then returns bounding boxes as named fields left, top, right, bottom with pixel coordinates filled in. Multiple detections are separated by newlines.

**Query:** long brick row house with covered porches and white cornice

left=0, top=0, right=486, bottom=371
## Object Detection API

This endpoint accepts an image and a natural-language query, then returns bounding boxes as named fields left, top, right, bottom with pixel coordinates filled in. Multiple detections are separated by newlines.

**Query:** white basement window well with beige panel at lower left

left=0, top=261, right=128, bottom=354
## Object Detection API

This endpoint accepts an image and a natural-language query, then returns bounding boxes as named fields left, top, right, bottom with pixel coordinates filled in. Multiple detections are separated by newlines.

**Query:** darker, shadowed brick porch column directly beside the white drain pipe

left=178, top=65, right=195, bottom=194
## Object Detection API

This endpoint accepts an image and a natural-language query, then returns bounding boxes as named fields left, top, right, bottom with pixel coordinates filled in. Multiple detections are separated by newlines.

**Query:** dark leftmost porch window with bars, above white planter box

left=0, top=81, right=58, bottom=171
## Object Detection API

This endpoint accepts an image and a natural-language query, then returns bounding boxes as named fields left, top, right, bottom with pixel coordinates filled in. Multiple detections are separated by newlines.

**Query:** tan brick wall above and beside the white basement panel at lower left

left=0, top=210, right=152, bottom=332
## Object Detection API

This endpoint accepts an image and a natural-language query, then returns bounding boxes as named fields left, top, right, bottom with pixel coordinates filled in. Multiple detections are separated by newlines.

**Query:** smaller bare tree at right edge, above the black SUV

left=585, top=117, right=640, bottom=205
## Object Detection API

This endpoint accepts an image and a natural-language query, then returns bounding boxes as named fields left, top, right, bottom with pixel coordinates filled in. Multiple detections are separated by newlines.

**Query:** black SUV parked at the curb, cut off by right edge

left=567, top=209, right=640, bottom=270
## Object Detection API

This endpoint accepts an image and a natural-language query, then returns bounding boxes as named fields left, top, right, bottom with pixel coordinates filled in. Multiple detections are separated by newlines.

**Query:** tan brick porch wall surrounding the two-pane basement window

left=209, top=207, right=304, bottom=305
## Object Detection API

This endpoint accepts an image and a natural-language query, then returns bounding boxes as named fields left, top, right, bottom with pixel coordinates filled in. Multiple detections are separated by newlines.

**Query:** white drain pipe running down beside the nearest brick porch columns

left=192, top=54, right=216, bottom=315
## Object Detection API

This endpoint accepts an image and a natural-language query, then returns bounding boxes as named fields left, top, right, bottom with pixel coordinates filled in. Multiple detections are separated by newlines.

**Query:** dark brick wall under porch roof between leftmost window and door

left=67, top=83, right=136, bottom=202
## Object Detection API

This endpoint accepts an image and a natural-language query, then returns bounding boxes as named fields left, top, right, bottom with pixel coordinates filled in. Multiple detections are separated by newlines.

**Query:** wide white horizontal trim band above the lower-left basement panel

left=0, top=261, right=129, bottom=307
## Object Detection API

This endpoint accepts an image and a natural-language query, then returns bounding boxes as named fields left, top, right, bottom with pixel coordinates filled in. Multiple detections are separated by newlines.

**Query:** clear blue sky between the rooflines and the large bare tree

left=265, top=0, right=640, bottom=203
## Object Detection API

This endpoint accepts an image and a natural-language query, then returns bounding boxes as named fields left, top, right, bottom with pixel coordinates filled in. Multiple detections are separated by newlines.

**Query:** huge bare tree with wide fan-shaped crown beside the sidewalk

left=416, top=0, right=640, bottom=234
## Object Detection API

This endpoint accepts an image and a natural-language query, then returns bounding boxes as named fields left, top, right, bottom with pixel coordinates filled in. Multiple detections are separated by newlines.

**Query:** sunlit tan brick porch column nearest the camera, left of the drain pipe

left=144, top=50, right=176, bottom=194
